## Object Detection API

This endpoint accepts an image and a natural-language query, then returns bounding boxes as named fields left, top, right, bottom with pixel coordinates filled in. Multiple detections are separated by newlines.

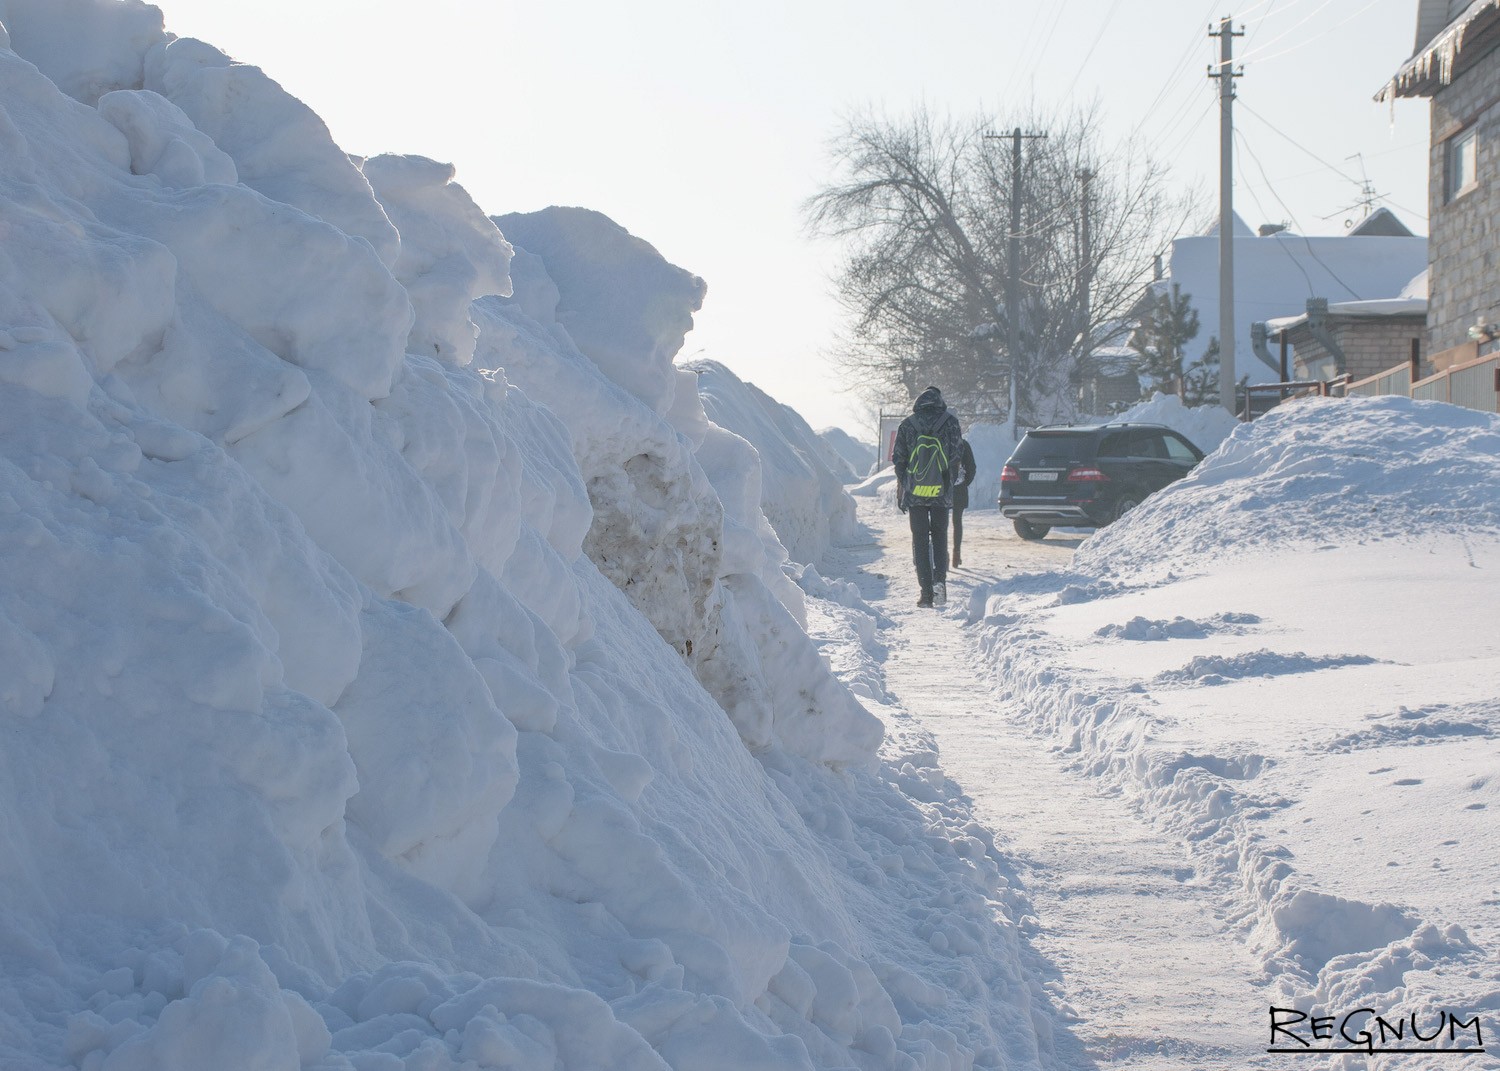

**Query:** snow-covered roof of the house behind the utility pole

left=1157, top=210, right=1422, bottom=384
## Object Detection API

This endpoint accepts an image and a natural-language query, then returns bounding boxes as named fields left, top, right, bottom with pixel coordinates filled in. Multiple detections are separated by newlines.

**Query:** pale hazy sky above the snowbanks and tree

left=146, top=0, right=1427, bottom=440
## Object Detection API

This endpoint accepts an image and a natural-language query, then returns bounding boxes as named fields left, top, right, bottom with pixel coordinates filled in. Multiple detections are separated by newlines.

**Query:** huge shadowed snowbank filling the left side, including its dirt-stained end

left=0, top=0, right=1043, bottom=1071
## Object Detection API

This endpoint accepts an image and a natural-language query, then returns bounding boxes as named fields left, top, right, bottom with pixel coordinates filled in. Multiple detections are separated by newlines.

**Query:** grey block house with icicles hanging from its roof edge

left=1376, top=0, right=1500, bottom=369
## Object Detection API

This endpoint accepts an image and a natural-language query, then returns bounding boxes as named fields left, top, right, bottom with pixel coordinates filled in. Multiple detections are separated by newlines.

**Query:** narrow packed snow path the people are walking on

left=851, top=497, right=1269, bottom=1071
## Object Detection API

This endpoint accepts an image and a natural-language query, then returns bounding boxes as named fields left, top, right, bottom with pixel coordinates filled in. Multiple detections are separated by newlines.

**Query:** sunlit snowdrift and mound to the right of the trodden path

left=968, top=399, right=1500, bottom=1022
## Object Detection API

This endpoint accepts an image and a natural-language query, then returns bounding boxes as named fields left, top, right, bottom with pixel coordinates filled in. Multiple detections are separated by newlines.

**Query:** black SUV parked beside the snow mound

left=1001, top=425, right=1203, bottom=539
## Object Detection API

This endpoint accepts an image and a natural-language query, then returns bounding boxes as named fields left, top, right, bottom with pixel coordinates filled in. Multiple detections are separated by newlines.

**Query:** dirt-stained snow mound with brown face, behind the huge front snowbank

left=474, top=209, right=881, bottom=764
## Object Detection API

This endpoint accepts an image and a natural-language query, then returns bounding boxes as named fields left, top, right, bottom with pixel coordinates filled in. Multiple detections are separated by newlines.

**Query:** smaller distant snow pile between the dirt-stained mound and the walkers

left=683, top=360, right=857, bottom=563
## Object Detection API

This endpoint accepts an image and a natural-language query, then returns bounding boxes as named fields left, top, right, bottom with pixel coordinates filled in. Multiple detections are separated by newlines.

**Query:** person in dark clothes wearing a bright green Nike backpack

left=891, top=387, right=963, bottom=606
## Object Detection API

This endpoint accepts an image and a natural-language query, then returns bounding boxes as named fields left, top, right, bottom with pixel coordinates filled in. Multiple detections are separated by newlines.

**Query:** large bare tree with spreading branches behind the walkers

left=806, top=110, right=1193, bottom=423
